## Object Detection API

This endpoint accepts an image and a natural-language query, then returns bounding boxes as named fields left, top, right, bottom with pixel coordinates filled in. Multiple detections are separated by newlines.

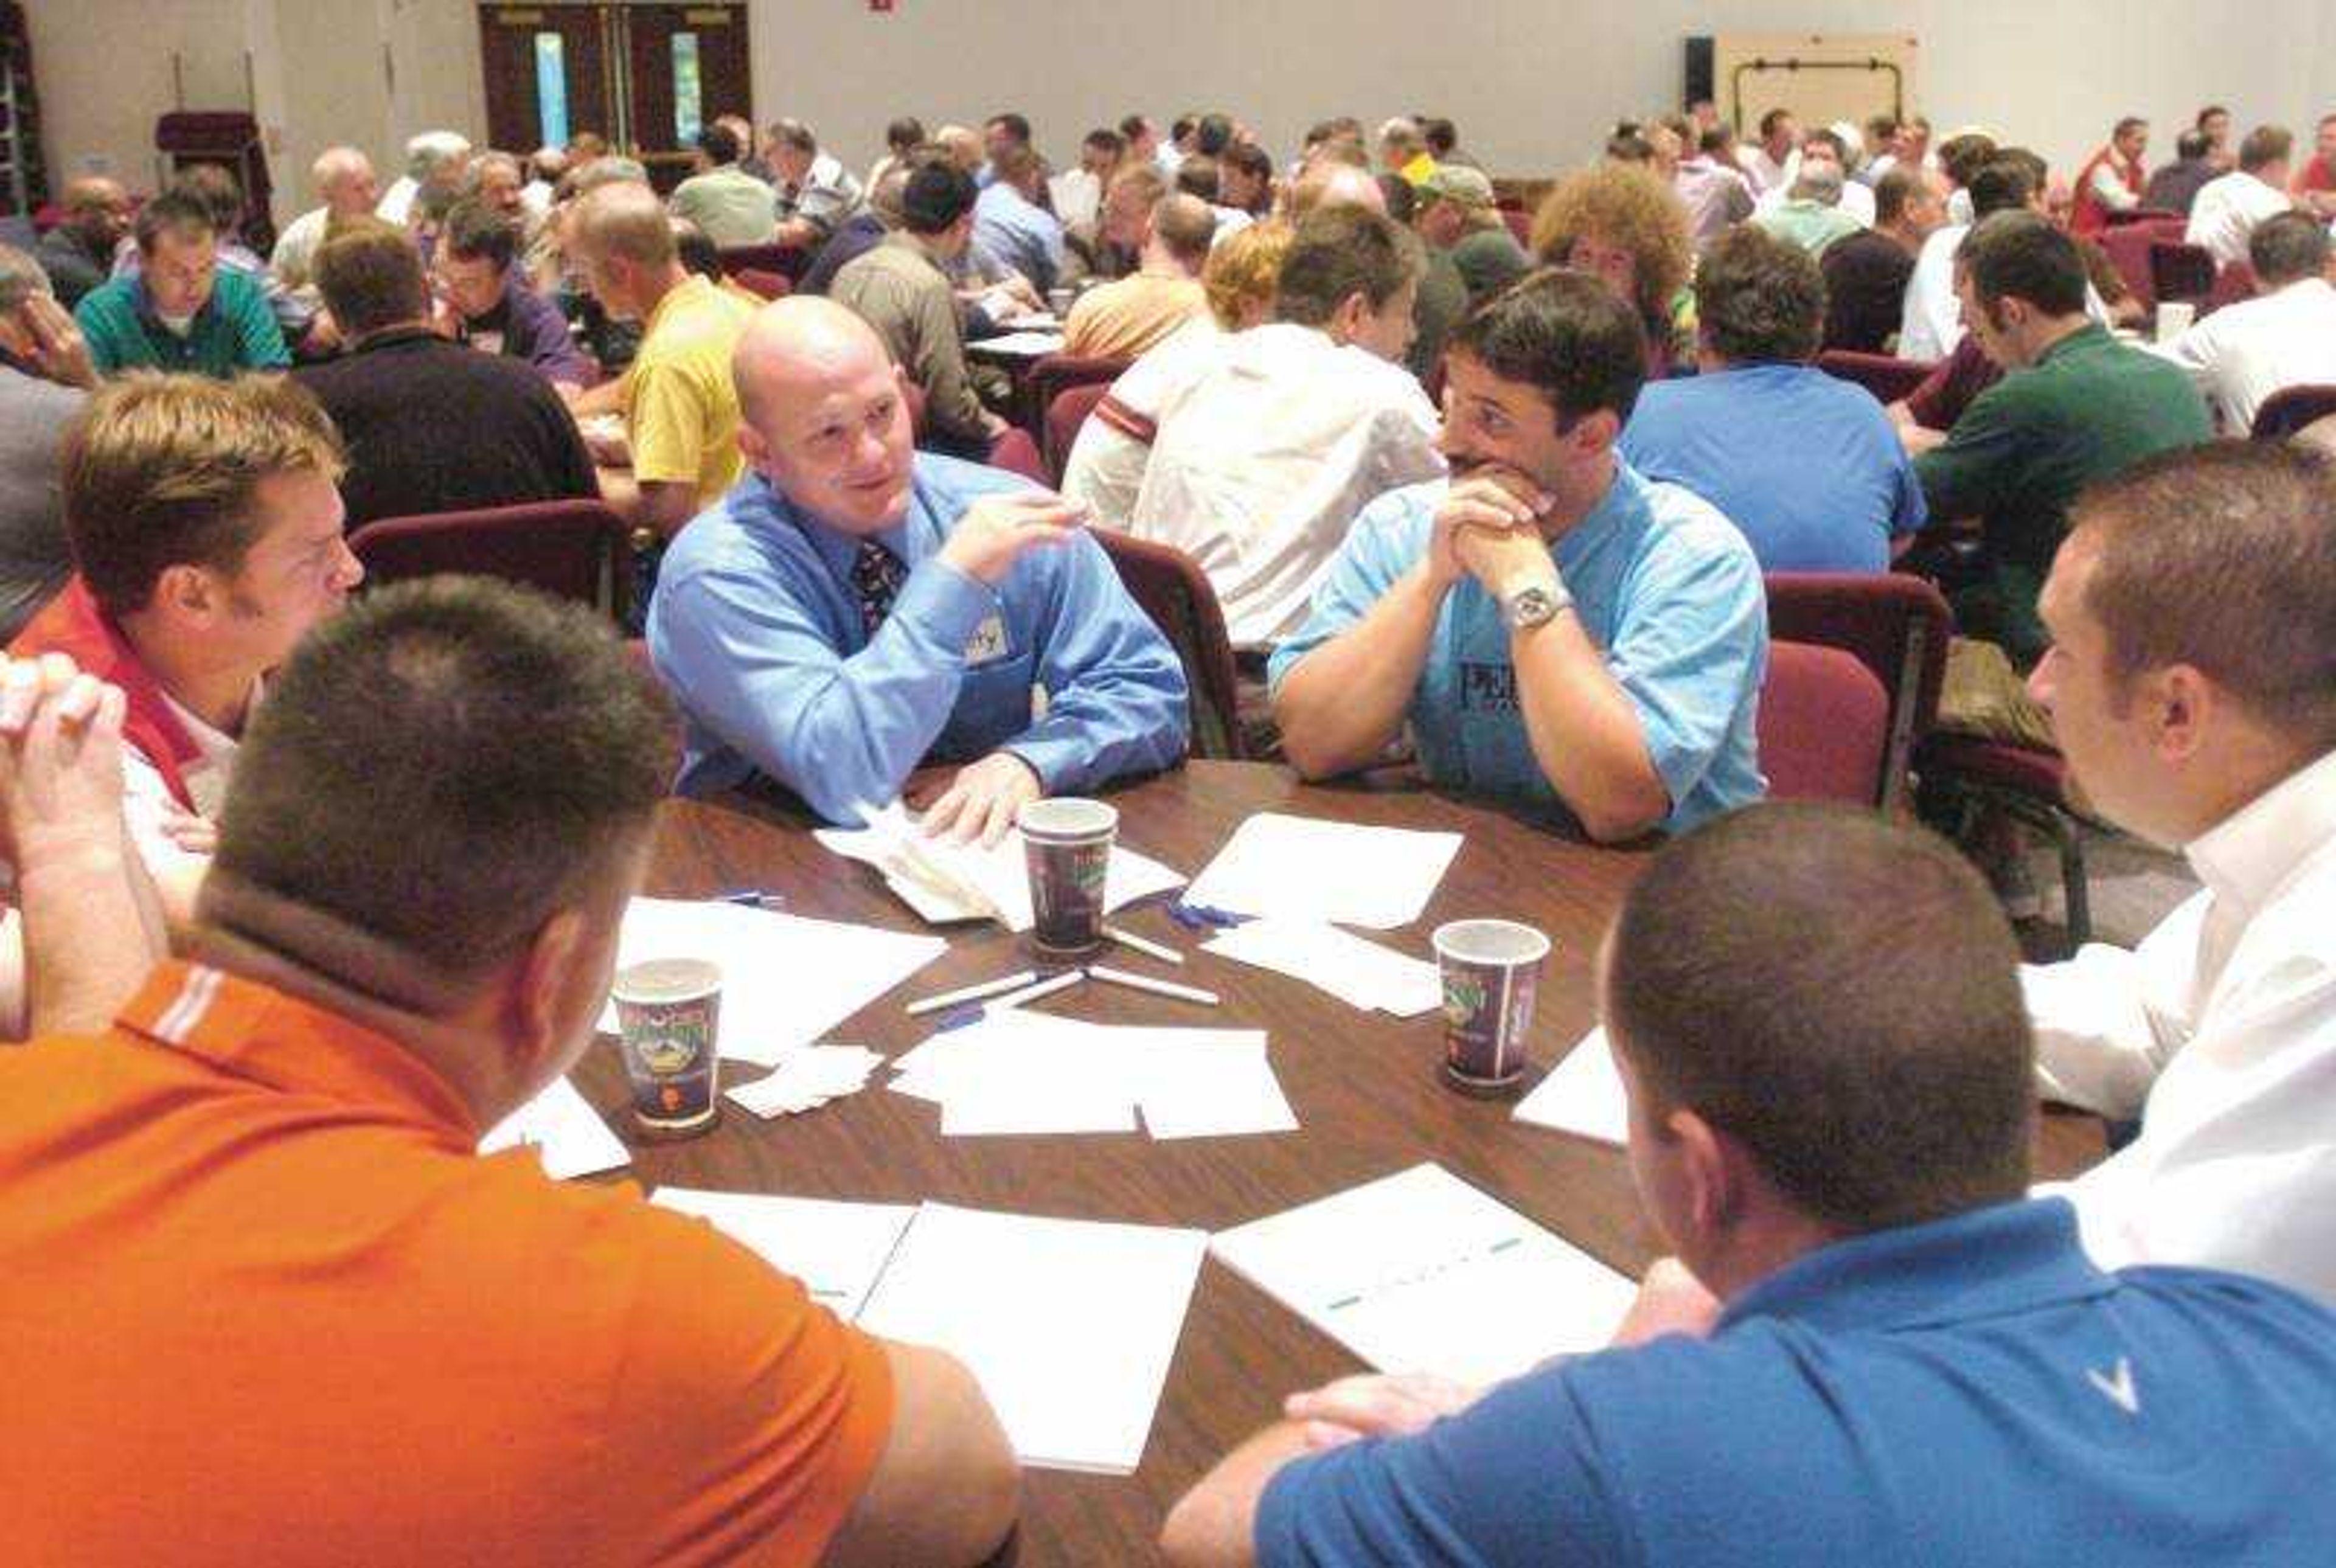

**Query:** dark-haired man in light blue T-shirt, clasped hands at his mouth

left=1271, top=271, right=1768, bottom=841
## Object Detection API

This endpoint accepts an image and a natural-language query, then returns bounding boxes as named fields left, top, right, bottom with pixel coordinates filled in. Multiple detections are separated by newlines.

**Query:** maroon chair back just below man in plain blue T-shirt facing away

left=1766, top=572, right=1955, bottom=811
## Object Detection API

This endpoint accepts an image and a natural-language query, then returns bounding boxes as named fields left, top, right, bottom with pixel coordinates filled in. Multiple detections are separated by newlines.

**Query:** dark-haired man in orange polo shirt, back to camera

left=0, top=577, right=1016, bottom=1568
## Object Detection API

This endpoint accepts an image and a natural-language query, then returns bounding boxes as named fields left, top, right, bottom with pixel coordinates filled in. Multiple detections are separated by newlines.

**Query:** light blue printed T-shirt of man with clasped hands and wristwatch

left=1268, top=463, right=1768, bottom=832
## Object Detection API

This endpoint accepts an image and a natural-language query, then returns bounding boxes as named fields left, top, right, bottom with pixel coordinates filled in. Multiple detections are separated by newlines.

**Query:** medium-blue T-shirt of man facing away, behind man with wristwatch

left=1621, top=364, right=1930, bottom=572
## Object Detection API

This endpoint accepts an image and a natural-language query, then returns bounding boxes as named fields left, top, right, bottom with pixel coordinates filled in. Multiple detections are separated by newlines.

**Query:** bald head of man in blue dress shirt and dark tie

left=731, top=294, right=916, bottom=538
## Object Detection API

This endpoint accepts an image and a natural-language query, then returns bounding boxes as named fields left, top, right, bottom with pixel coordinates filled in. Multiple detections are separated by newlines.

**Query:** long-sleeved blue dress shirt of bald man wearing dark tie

left=650, top=453, right=1184, bottom=822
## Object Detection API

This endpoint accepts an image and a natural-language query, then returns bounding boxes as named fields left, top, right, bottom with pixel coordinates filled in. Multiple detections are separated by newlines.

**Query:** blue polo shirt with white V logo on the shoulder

left=1257, top=1199, right=2336, bottom=1568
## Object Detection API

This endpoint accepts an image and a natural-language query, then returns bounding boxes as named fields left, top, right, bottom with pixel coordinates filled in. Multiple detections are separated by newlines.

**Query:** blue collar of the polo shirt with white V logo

left=1719, top=1199, right=2116, bottom=1332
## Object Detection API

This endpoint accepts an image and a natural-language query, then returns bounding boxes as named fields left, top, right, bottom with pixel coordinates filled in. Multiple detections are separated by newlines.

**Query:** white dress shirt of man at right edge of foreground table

left=2023, top=752, right=2336, bottom=1302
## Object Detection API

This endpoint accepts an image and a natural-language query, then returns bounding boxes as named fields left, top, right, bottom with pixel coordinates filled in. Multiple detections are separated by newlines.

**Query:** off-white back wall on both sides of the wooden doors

left=33, top=0, right=2336, bottom=215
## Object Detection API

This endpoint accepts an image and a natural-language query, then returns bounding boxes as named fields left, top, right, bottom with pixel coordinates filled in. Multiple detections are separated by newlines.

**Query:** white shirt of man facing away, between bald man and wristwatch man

left=1128, top=322, right=1444, bottom=647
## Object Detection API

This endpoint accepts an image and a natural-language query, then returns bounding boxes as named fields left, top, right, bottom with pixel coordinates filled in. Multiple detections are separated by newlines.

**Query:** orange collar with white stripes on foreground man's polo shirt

left=119, top=958, right=481, bottom=1147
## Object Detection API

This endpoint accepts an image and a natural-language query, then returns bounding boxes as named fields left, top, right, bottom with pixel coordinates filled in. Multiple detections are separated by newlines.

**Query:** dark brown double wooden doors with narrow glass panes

left=479, top=5, right=754, bottom=187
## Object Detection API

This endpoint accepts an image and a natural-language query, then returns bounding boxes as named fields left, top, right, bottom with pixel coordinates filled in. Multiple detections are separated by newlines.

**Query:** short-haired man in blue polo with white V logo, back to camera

left=1166, top=806, right=2336, bottom=1568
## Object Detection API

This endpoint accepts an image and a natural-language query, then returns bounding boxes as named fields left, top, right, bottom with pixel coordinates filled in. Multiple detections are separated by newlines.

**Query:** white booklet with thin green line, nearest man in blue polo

left=1212, top=1166, right=1633, bottom=1383
